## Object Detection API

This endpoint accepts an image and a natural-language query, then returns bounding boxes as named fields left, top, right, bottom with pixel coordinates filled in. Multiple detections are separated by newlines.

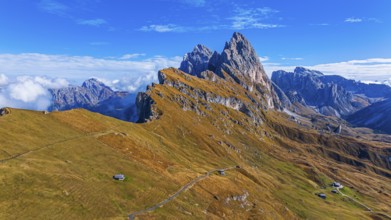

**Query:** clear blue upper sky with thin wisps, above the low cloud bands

left=0, top=0, right=391, bottom=62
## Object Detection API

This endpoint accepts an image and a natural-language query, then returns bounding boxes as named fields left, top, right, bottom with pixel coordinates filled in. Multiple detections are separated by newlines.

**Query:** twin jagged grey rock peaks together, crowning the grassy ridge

left=179, top=32, right=279, bottom=108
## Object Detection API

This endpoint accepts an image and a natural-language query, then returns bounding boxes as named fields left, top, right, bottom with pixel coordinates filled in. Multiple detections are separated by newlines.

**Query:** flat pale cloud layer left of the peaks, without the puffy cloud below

left=0, top=53, right=182, bottom=91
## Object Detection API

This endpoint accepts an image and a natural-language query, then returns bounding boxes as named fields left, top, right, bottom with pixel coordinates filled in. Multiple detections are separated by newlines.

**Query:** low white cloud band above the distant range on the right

left=263, top=58, right=391, bottom=81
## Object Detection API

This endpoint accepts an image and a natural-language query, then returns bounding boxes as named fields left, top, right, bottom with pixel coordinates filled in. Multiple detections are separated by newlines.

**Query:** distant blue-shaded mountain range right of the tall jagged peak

left=272, top=67, right=391, bottom=133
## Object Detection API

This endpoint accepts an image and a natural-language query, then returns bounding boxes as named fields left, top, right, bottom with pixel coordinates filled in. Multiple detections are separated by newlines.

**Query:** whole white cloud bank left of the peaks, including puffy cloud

left=0, top=53, right=181, bottom=110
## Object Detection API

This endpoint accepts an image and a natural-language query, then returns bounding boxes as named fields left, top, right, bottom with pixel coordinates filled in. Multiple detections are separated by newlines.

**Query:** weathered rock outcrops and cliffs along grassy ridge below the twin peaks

left=137, top=68, right=267, bottom=125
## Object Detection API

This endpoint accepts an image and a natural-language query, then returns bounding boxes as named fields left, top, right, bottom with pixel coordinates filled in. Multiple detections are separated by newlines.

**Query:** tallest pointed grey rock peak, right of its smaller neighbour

left=221, top=32, right=270, bottom=87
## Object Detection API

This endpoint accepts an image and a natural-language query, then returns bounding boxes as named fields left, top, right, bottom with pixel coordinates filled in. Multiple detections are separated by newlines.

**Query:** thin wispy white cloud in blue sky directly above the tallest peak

left=228, top=7, right=283, bottom=30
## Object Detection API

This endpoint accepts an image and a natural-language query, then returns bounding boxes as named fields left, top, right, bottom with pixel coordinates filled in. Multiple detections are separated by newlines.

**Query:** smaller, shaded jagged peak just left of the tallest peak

left=179, top=44, right=212, bottom=76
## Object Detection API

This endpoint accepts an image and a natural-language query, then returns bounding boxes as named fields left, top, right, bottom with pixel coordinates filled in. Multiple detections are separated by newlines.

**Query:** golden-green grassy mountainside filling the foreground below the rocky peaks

left=0, top=70, right=391, bottom=219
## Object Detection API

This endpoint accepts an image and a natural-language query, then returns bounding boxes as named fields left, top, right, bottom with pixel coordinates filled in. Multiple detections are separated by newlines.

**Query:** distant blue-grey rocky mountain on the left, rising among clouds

left=49, top=79, right=136, bottom=121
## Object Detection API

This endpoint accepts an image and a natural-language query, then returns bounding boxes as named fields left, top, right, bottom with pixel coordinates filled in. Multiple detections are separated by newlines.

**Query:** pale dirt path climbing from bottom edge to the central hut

left=128, top=166, right=237, bottom=220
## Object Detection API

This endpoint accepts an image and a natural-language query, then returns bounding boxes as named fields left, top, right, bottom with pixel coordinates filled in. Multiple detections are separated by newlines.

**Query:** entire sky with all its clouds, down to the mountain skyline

left=0, top=0, right=391, bottom=109
